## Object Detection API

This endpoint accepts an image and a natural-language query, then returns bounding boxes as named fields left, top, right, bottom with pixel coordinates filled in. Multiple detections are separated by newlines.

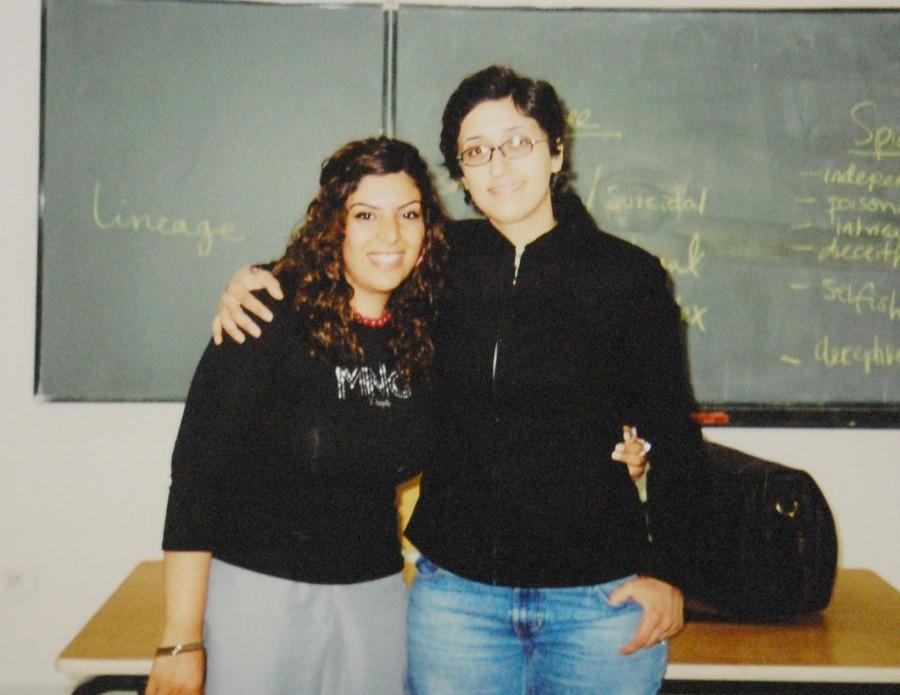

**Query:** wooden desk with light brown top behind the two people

left=56, top=562, right=900, bottom=695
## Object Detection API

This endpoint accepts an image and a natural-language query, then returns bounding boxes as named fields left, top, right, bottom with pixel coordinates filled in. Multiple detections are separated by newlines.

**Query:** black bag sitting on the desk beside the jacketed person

left=687, top=442, right=837, bottom=621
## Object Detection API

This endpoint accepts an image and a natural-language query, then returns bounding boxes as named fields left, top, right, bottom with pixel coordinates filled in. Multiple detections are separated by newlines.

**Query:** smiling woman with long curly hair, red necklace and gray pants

left=147, top=138, right=444, bottom=695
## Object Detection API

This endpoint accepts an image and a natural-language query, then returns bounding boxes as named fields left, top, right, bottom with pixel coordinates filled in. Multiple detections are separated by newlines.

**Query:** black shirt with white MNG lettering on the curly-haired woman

left=163, top=300, right=432, bottom=584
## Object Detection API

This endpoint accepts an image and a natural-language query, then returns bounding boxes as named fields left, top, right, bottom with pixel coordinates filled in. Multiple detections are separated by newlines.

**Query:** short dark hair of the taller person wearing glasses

left=441, top=65, right=571, bottom=196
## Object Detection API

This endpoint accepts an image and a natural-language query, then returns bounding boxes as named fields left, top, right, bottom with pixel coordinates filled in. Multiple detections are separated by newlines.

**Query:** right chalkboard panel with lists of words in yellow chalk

left=397, top=8, right=900, bottom=425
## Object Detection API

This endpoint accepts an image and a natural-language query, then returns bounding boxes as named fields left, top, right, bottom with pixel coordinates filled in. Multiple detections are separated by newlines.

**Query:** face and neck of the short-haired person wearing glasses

left=457, top=97, right=563, bottom=244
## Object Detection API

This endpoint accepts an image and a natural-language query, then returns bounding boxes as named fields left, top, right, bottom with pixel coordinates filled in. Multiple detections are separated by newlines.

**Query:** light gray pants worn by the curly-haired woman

left=204, top=559, right=408, bottom=695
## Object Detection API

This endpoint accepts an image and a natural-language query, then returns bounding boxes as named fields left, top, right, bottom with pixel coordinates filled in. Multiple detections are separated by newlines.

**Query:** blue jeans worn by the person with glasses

left=407, top=557, right=668, bottom=695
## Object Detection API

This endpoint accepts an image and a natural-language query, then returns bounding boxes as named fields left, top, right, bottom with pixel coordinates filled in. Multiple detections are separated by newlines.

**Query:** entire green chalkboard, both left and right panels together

left=38, top=0, right=900, bottom=425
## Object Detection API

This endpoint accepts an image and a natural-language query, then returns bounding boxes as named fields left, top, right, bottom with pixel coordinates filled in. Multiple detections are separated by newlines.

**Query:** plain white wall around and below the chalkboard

left=0, top=0, right=900, bottom=694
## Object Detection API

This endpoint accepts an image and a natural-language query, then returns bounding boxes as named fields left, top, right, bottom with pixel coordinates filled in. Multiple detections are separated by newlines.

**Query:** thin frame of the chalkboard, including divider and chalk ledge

left=34, top=0, right=900, bottom=428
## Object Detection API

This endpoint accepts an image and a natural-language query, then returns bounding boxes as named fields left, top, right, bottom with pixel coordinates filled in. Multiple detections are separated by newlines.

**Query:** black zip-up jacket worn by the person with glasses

left=406, top=196, right=706, bottom=587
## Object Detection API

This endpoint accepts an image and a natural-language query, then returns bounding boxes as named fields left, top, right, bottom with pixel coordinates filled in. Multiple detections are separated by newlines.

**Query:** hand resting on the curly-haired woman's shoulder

left=212, top=266, right=284, bottom=345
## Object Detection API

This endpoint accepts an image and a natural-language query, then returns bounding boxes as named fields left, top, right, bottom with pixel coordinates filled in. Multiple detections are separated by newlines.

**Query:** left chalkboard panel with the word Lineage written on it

left=38, top=0, right=384, bottom=400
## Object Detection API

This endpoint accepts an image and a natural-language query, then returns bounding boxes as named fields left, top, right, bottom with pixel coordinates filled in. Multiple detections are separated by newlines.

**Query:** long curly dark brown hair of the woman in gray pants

left=274, top=137, right=447, bottom=380
